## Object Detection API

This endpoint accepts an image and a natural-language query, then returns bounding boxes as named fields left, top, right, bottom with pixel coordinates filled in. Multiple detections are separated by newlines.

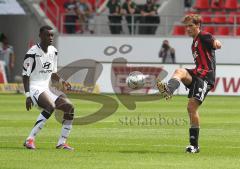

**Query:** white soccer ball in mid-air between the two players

left=126, top=71, right=145, bottom=89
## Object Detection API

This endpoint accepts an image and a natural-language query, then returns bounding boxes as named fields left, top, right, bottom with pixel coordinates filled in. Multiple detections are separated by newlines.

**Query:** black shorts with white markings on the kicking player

left=185, top=69, right=212, bottom=104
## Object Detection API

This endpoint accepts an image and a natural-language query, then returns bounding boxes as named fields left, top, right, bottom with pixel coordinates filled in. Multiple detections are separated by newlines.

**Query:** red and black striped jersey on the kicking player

left=192, top=32, right=216, bottom=86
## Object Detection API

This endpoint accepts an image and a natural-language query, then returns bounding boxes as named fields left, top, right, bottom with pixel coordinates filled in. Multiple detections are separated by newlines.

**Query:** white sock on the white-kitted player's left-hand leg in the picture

left=27, top=113, right=47, bottom=139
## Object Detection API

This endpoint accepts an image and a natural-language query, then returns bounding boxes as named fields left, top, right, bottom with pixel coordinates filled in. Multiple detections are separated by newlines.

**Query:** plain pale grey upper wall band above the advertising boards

left=57, top=35, right=240, bottom=66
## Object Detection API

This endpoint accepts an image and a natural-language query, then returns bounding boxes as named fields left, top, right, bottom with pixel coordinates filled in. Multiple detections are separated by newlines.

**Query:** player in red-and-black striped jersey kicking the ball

left=157, top=14, right=222, bottom=153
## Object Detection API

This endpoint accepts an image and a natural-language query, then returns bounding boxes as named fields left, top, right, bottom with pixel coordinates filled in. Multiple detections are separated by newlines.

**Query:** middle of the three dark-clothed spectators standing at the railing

left=122, top=0, right=137, bottom=34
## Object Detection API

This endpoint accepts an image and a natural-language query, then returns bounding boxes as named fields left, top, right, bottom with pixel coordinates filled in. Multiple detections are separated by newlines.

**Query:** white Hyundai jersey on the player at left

left=22, top=44, right=57, bottom=88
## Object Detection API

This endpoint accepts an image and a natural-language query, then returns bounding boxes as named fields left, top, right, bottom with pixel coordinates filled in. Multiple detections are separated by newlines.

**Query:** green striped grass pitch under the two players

left=0, top=94, right=240, bottom=169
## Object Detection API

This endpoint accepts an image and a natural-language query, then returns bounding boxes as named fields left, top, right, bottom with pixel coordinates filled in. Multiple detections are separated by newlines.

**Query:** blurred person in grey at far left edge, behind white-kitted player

left=0, top=34, right=15, bottom=82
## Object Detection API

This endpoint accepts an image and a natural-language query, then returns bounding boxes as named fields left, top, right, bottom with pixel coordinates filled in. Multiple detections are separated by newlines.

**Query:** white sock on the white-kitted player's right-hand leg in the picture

left=57, top=120, right=73, bottom=145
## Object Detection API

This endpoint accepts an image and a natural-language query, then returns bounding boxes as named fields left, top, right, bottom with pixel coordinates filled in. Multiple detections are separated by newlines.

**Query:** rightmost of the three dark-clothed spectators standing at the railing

left=139, top=0, right=160, bottom=35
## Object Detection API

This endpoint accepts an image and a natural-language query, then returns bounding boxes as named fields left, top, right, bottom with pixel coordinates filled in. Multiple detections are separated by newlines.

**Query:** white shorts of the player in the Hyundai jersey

left=30, top=85, right=64, bottom=106
